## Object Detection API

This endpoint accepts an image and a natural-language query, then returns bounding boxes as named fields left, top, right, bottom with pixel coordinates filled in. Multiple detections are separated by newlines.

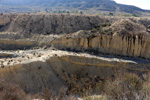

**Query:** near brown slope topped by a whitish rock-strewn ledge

left=0, top=50, right=150, bottom=94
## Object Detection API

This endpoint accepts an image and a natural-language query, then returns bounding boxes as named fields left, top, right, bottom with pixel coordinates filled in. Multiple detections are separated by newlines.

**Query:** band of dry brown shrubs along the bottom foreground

left=0, top=73, right=150, bottom=100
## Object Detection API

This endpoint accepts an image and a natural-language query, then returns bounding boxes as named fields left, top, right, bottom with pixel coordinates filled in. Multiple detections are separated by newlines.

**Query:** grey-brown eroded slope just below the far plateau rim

left=5, top=14, right=108, bottom=34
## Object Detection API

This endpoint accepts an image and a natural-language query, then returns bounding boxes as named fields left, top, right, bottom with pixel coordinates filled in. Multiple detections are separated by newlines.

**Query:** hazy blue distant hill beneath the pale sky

left=0, top=0, right=150, bottom=13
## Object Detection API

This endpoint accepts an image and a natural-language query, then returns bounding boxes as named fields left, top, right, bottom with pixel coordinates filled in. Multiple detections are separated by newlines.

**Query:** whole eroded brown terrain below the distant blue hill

left=0, top=13, right=150, bottom=100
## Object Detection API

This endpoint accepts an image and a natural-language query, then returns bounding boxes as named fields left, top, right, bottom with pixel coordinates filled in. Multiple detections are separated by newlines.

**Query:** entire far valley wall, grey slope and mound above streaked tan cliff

left=0, top=14, right=150, bottom=58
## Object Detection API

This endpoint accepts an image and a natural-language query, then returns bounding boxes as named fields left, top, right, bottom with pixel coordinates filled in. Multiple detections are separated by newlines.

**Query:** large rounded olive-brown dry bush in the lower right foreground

left=104, top=73, right=143, bottom=100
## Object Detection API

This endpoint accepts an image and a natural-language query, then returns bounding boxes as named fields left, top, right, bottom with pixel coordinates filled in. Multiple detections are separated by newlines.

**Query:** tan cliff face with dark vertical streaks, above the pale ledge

left=53, top=35, right=150, bottom=58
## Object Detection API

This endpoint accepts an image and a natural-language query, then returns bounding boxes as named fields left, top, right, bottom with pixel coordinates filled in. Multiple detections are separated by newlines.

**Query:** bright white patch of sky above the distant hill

left=114, top=0, right=150, bottom=10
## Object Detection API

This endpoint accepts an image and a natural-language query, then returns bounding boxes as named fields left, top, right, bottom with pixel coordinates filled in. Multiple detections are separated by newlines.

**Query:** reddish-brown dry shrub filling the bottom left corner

left=0, top=80, right=29, bottom=100
